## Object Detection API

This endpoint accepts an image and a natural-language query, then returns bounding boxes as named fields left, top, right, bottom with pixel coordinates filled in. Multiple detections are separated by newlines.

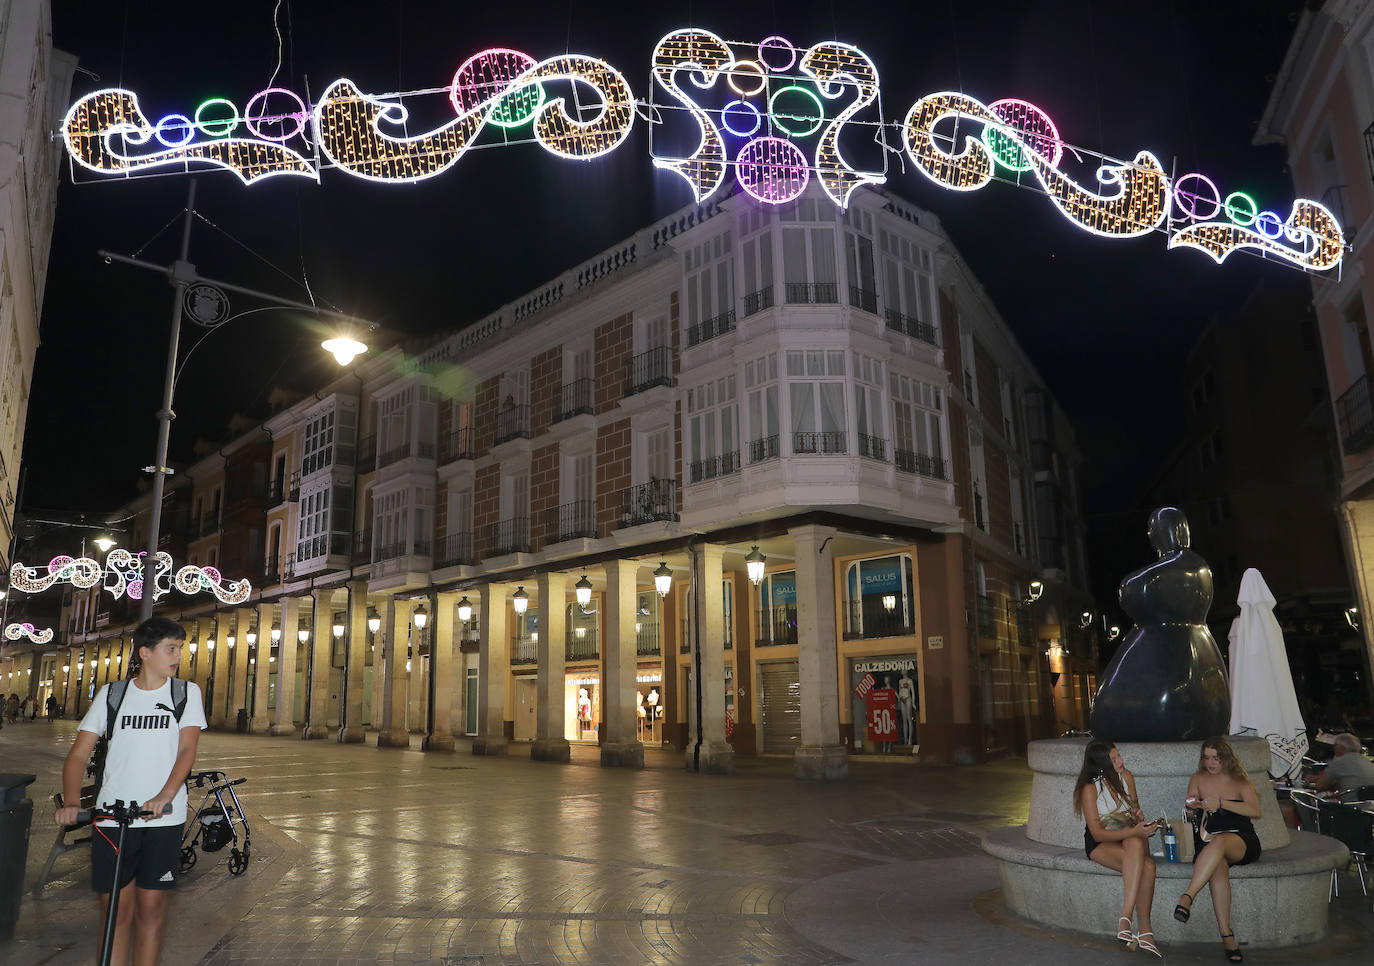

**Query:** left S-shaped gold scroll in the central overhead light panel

left=649, top=29, right=735, bottom=203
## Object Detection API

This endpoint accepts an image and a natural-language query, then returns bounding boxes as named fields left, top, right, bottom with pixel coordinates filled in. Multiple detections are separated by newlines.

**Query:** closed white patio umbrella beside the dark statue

left=1230, top=568, right=1307, bottom=778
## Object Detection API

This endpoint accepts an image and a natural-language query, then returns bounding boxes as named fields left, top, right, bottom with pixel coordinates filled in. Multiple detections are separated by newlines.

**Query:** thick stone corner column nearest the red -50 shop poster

left=787, top=526, right=849, bottom=779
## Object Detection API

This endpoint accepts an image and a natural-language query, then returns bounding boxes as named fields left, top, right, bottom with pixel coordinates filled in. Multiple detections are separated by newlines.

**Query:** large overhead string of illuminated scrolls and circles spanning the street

left=62, top=27, right=1345, bottom=272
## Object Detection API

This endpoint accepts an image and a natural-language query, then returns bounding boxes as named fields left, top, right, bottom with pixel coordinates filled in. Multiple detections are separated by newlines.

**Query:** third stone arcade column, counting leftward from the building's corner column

left=602, top=561, right=644, bottom=768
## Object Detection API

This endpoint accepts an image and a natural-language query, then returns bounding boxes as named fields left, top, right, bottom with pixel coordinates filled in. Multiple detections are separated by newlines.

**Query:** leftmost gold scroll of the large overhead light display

left=62, top=88, right=319, bottom=184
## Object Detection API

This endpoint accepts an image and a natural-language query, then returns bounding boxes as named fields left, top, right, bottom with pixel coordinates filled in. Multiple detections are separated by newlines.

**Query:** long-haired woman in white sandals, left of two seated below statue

left=1073, top=738, right=1162, bottom=959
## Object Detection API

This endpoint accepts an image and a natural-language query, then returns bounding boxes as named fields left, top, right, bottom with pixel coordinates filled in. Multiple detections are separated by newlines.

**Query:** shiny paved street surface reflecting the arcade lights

left=0, top=721, right=1374, bottom=966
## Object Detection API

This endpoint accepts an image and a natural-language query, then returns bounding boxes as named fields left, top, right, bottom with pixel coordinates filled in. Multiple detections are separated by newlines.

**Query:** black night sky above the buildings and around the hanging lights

left=32, top=0, right=1308, bottom=604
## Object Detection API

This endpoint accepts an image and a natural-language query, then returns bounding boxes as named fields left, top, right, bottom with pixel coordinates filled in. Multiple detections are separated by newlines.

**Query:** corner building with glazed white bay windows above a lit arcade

left=59, top=182, right=1095, bottom=778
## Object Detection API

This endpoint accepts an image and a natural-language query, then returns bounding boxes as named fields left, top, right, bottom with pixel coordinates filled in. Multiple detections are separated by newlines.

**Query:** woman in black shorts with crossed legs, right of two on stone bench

left=1173, top=738, right=1260, bottom=963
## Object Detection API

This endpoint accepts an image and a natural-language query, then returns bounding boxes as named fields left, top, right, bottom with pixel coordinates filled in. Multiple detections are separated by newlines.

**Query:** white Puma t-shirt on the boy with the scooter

left=81, top=677, right=206, bottom=827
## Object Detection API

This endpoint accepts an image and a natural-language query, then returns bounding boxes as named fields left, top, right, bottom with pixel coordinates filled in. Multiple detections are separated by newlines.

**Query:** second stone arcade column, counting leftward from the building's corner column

left=684, top=544, right=735, bottom=775
